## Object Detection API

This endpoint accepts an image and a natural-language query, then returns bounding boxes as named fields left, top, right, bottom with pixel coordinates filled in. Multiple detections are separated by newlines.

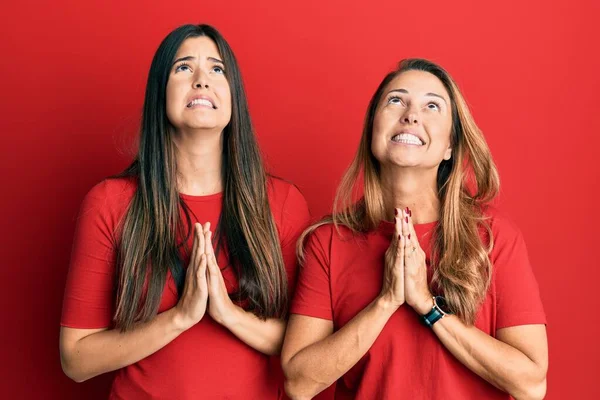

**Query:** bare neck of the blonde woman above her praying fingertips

left=381, top=166, right=440, bottom=224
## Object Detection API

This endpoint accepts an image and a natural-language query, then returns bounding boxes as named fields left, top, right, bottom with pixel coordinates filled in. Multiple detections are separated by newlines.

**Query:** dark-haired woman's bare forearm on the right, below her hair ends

left=217, top=306, right=286, bottom=355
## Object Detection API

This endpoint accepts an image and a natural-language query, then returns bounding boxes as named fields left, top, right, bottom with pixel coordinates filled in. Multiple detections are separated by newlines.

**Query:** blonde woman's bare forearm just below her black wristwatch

left=433, top=315, right=546, bottom=399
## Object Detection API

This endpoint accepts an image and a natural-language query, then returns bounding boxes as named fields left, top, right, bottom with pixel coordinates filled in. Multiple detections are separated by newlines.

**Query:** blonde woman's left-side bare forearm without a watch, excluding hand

left=284, top=298, right=397, bottom=399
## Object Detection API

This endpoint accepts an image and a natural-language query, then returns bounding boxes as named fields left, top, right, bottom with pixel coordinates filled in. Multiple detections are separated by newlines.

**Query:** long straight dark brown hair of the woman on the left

left=114, top=25, right=288, bottom=331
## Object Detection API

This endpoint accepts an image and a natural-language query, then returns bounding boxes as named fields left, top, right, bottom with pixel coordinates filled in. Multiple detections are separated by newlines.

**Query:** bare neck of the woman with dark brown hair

left=173, top=130, right=223, bottom=196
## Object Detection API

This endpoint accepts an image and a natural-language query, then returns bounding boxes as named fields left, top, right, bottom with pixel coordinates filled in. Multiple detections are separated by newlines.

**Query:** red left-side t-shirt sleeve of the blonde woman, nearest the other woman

left=290, top=226, right=333, bottom=320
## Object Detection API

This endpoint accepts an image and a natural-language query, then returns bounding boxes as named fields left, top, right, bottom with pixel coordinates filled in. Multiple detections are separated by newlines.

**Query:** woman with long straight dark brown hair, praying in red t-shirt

left=60, top=25, right=309, bottom=399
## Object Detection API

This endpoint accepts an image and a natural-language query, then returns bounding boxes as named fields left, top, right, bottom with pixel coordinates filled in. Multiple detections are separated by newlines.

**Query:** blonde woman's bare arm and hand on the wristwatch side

left=402, top=209, right=548, bottom=399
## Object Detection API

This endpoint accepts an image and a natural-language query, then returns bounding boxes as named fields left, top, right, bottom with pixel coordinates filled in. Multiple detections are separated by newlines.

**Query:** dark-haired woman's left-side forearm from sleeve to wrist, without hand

left=61, top=308, right=184, bottom=382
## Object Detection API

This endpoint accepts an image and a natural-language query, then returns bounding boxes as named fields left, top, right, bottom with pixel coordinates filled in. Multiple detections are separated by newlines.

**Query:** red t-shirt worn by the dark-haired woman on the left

left=61, top=178, right=309, bottom=400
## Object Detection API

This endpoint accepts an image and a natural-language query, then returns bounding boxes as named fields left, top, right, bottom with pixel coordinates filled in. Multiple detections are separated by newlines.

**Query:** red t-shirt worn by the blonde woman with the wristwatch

left=291, top=209, right=546, bottom=400
